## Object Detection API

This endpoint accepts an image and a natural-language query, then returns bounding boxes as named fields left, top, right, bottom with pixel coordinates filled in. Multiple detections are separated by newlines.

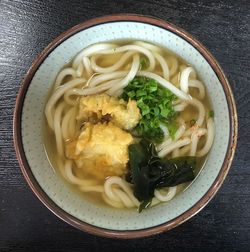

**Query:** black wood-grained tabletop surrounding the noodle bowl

left=0, top=0, right=250, bottom=252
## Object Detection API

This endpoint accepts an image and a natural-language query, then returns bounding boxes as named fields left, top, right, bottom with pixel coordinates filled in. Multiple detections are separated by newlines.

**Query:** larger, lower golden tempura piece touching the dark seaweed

left=65, top=122, right=133, bottom=179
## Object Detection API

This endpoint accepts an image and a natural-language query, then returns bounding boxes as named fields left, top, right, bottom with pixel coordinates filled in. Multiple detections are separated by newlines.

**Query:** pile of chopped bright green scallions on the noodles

left=121, top=77, right=177, bottom=143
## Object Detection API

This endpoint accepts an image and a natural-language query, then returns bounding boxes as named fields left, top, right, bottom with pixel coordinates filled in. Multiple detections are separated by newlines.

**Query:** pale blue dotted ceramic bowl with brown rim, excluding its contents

left=14, top=14, right=237, bottom=238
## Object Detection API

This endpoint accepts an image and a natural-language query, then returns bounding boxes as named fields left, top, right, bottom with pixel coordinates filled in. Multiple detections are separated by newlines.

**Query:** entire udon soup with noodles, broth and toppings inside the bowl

left=45, top=41, right=214, bottom=212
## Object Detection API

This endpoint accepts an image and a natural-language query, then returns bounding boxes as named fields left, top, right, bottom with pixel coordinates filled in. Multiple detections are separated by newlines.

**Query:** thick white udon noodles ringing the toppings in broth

left=45, top=41, right=215, bottom=211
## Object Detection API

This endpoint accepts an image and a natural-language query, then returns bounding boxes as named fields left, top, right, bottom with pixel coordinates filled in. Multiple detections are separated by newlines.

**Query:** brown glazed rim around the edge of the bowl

left=13, top=13, right=238, bottom=239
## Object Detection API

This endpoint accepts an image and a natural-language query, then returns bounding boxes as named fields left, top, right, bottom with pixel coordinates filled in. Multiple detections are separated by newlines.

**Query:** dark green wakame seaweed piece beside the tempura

left=126, top=139, right=196, bottom=212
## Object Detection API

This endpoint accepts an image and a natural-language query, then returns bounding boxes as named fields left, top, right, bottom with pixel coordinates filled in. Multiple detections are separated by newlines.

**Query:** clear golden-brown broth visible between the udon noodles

left=43, top=40, right=215, bottom=211
